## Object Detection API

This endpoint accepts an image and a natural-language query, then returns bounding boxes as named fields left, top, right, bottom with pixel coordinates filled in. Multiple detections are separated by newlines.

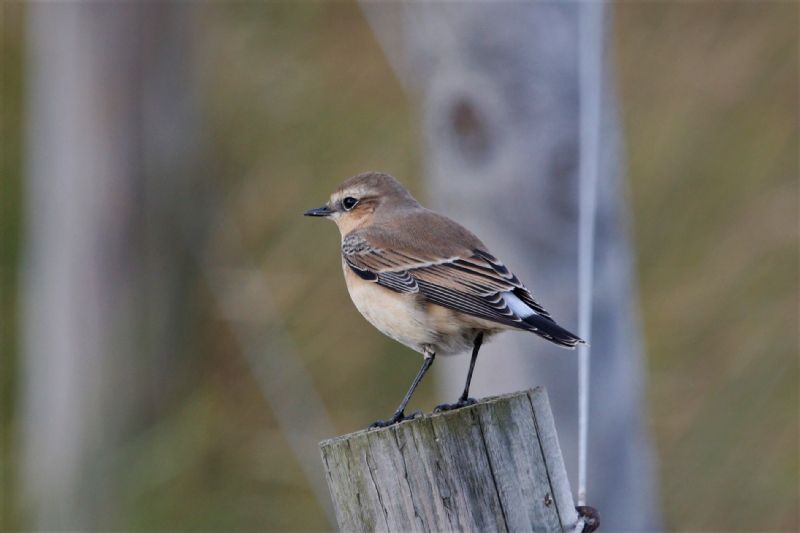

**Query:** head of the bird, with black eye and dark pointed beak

left=304, top=172, right=419, bottom=235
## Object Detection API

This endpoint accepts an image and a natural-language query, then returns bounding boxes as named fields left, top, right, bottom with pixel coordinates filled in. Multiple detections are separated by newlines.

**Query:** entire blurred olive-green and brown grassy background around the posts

left=0, top=2, right=800, bottom=531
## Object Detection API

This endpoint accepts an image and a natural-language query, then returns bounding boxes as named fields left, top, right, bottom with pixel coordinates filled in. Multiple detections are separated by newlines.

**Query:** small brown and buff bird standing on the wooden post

left=305, top=172, right=583, bottom=427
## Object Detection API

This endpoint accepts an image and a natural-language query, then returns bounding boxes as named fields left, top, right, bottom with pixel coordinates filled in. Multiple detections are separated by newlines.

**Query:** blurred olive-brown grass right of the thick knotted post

left=616, top=2, right=800, bottom=530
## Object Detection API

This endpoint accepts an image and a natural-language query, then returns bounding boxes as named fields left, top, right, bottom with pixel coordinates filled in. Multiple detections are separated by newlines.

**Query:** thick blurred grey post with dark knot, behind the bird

left=363, top=2, right=660, bottom=531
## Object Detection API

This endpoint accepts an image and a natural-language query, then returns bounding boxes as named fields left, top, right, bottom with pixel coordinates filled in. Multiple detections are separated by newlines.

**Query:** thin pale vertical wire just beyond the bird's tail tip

left=577, top=0, right=603, bottom=512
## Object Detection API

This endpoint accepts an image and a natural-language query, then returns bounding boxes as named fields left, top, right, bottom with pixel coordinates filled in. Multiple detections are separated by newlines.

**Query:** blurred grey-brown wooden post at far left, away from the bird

left=20, top=2, right=203, bottom=530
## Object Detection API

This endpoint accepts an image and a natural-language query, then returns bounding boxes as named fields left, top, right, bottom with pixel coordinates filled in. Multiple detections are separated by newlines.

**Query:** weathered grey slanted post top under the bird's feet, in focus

left=320, top=387, right=578, bottom=532
